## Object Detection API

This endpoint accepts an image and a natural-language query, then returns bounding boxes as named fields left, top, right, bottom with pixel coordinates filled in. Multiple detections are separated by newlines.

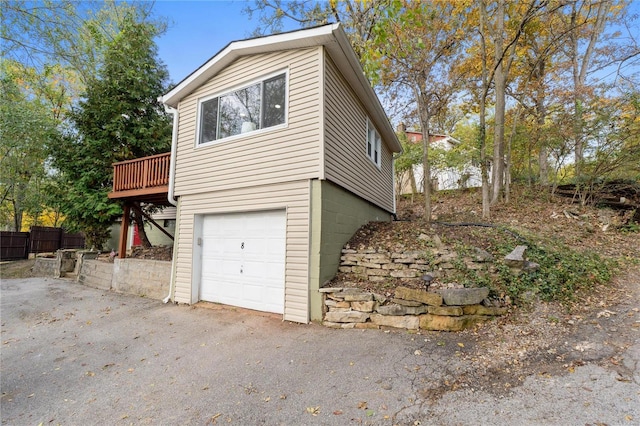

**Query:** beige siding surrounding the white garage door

left=174, top=180, right=310, bottom=323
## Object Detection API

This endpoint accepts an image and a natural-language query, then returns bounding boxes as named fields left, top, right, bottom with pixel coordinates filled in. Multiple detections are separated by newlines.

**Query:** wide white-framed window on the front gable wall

left=198, top=73, right=287, bottom=144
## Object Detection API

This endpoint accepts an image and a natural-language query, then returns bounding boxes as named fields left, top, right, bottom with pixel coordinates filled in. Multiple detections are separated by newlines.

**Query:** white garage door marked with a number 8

left=200, top=210, right=286, bottom=313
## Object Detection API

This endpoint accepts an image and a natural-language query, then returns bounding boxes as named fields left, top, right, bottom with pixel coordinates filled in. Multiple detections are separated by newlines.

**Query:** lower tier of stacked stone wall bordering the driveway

left=320, top=287, right=507, bottom=331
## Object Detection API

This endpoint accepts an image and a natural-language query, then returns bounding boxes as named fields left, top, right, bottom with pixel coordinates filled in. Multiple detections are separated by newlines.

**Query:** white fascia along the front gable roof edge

left=162, top=24, right=339, bottom=108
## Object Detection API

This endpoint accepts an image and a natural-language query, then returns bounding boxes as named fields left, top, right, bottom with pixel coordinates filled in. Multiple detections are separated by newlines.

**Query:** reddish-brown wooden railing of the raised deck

left=113, top=152, right=171, bottom=192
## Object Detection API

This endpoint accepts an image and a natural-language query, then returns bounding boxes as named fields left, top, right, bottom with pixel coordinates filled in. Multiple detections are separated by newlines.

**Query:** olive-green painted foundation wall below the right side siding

left=309, top=180, right=391, bottom=321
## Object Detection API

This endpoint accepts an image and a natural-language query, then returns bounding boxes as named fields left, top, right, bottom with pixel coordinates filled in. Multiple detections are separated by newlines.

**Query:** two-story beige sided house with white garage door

left=162, top=24, right=401, bottom=323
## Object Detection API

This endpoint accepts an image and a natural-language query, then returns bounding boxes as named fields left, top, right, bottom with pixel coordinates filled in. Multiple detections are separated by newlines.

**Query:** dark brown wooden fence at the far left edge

left=0, top=226, right=84, bottom=260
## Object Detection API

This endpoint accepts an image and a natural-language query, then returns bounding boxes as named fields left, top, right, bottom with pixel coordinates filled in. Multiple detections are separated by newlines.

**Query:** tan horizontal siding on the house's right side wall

left=324, top=54, right=393, bottom=212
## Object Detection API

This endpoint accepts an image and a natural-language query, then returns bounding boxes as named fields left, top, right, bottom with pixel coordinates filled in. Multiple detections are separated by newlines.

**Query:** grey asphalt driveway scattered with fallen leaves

left=0, top=278, right=640, bottom=425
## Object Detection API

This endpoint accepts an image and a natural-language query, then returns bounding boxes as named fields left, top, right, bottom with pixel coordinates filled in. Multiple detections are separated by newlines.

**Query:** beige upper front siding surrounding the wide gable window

left=175, top=47, right=322, bottom=196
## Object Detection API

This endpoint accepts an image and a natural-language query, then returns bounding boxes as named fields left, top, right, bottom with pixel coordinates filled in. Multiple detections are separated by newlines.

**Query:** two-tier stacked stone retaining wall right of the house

left=320, top=243, right=507, bottom=331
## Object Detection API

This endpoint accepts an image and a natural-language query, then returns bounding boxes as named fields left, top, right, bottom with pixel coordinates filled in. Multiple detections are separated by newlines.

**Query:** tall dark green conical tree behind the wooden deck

left=51, top=14, right=171, bottom=247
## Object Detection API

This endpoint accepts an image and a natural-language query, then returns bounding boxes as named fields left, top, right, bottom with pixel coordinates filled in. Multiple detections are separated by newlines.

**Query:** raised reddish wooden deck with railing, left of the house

left=109, top=152, right=171, bottom=205
